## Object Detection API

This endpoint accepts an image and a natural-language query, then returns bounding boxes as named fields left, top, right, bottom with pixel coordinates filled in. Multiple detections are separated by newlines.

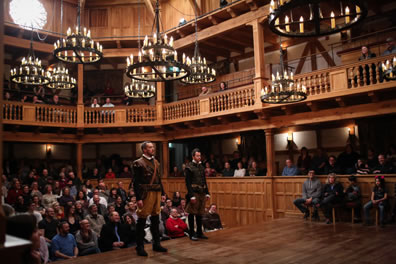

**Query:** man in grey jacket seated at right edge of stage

left=294, top=170, right=322, bottom=219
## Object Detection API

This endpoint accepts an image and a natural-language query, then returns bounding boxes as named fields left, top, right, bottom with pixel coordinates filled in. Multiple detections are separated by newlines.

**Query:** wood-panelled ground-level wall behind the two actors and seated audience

left=99, top=175, right=396, bottom=227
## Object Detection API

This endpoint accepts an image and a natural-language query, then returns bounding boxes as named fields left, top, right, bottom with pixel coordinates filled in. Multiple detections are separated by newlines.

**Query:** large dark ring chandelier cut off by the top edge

left=268, top=0, right=367, bottom=37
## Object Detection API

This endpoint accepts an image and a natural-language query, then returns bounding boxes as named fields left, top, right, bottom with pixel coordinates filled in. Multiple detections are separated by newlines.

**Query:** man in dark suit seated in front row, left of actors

left=99, top=211, right=127, bottom=252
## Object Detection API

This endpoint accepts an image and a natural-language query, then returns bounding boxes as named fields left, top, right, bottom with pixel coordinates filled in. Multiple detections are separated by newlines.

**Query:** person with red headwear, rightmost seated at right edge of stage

left=364, top=176, right=388, bottom=227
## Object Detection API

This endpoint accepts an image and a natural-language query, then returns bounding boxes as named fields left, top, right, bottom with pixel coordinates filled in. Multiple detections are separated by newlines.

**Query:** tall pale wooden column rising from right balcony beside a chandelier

left=248, top=18, right=266, bottom=107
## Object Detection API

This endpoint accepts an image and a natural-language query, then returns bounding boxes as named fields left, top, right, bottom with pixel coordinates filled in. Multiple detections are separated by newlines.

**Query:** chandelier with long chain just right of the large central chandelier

left=180, top=0, right=216, bottom=84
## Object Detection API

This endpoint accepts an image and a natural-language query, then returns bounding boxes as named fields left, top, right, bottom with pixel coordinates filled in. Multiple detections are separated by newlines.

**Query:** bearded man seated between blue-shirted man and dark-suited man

left=76, top=219, right=100, bottom=256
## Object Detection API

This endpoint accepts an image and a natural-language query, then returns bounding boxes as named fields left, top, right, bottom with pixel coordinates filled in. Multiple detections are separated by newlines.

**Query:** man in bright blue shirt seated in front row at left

left=52, top=222, right=78, bottom=260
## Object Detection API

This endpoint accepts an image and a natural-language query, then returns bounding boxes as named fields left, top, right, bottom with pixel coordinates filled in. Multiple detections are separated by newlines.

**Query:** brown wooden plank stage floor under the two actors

left=57, top=218, right=396, bottom=264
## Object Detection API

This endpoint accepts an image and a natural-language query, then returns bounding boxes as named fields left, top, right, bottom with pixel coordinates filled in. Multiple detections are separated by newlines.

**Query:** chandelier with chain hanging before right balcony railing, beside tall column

left=261, top=38, right=307, bottom=104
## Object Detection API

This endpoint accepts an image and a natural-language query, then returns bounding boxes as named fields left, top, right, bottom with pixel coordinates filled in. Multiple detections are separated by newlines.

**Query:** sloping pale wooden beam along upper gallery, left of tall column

left=174, top=5, right=269, bottom=49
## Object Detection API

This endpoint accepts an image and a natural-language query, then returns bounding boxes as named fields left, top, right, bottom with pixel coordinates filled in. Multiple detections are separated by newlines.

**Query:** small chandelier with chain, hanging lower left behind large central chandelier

left=124, top=1, right=155, bottom=98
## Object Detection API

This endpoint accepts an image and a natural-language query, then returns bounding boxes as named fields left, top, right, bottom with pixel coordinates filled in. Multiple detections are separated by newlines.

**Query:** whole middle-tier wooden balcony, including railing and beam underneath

left=3, top=56, right=396, bottom=132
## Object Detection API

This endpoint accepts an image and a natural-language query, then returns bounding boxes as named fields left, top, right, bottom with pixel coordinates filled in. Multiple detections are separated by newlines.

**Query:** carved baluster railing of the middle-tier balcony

left=3, top=55, right=396, bottom=128
